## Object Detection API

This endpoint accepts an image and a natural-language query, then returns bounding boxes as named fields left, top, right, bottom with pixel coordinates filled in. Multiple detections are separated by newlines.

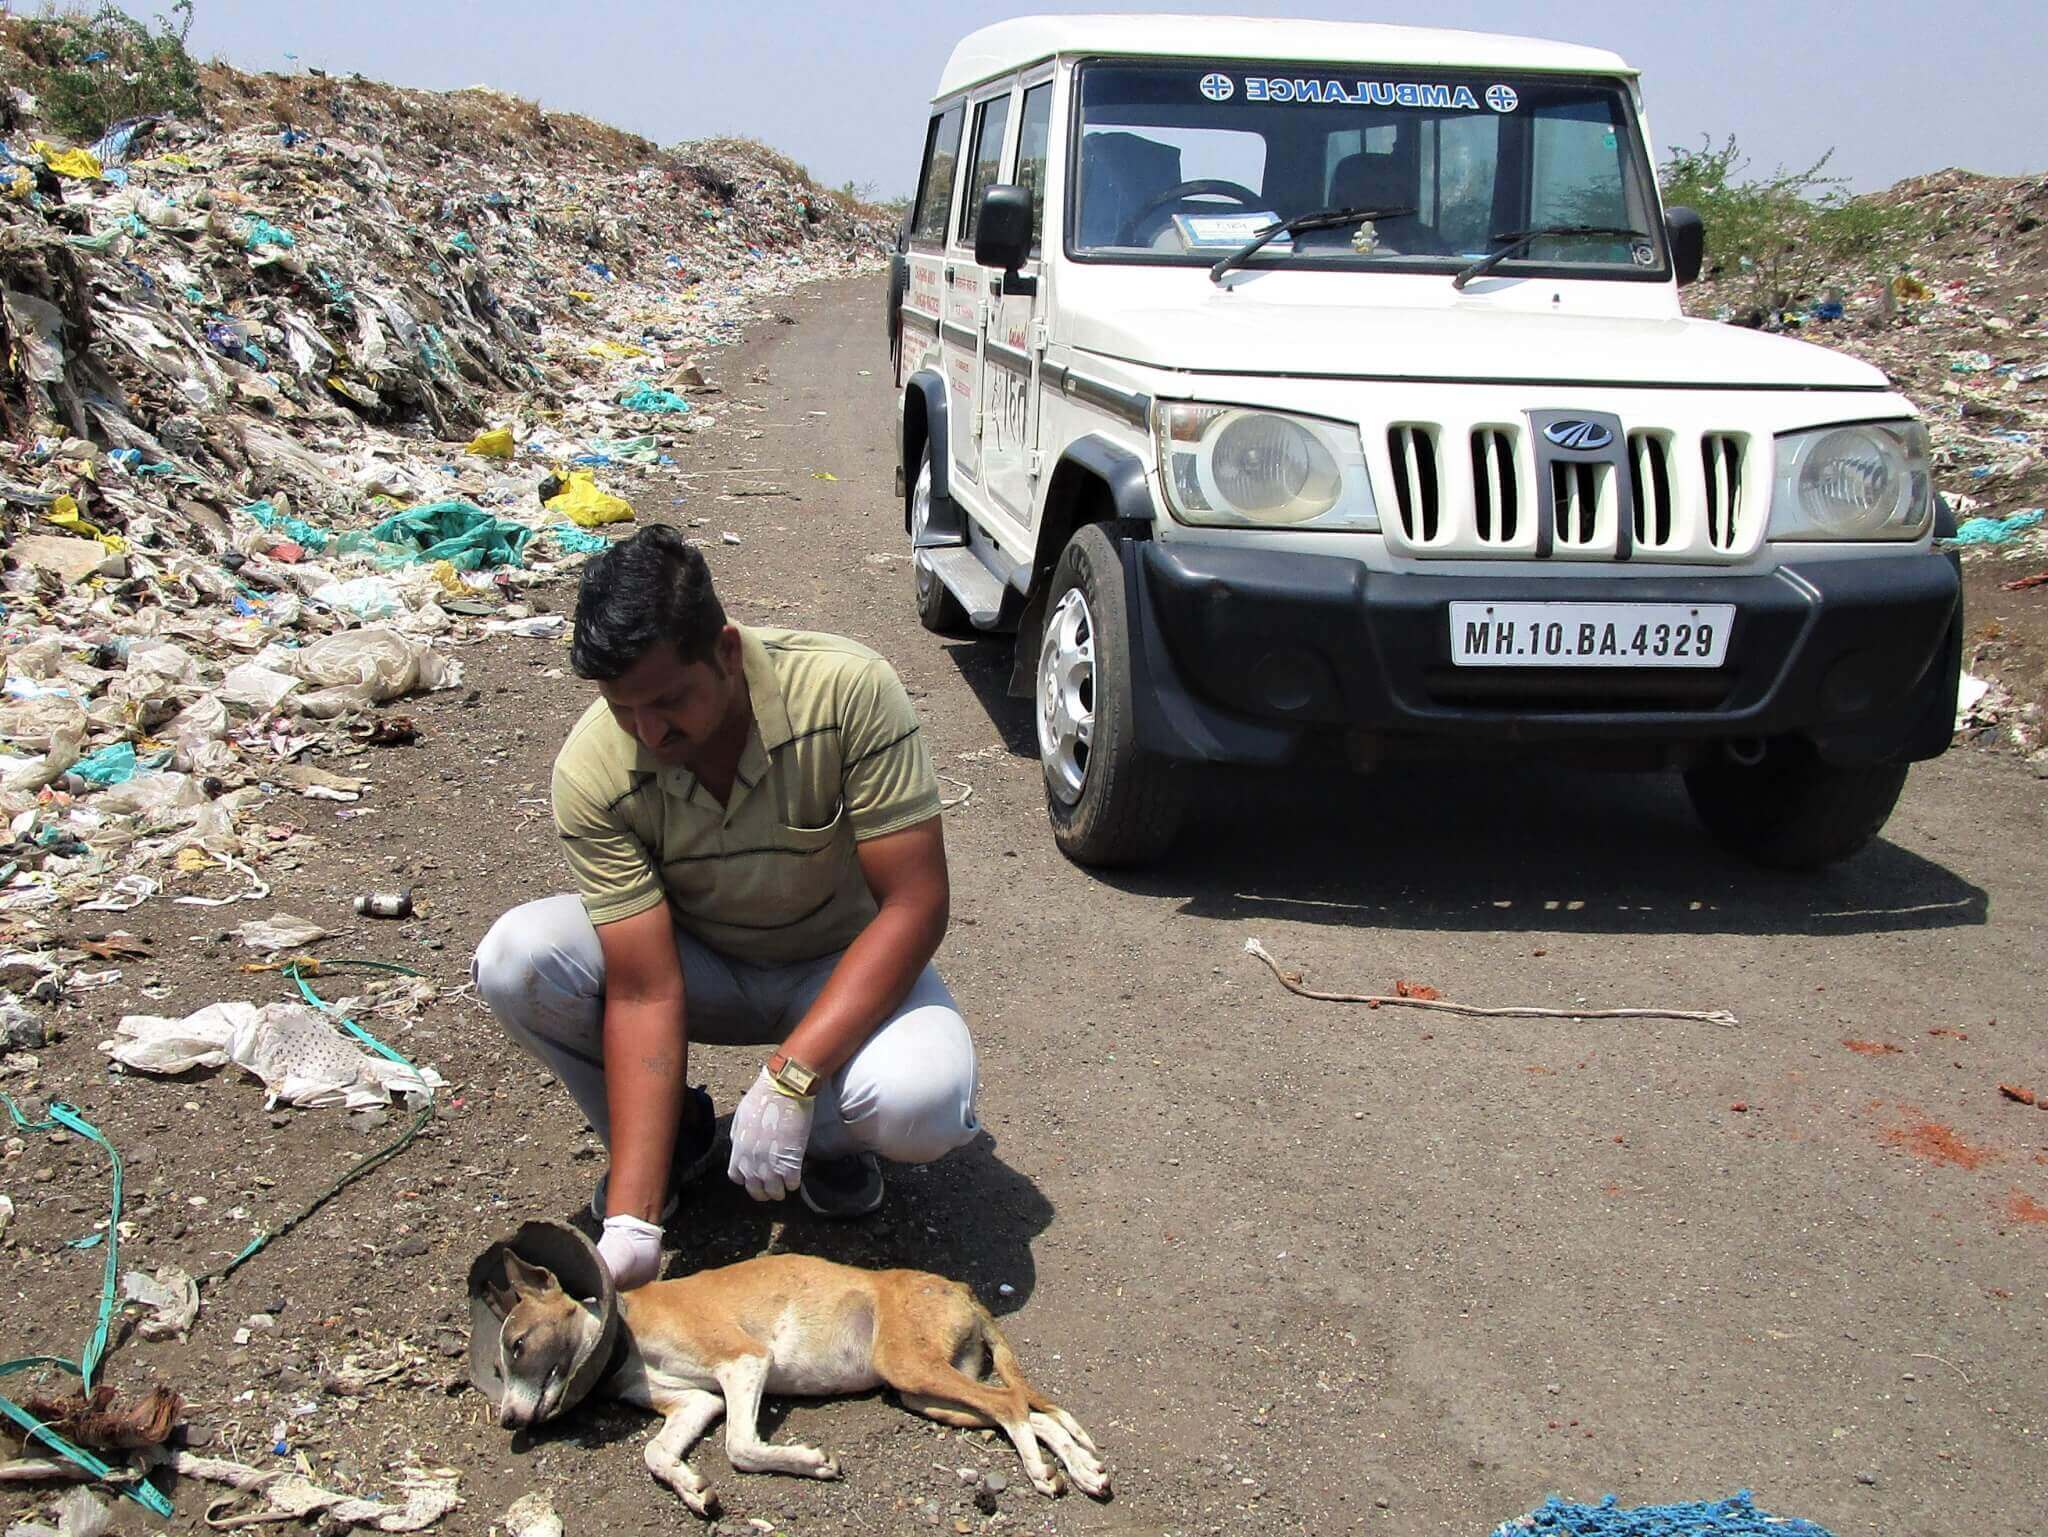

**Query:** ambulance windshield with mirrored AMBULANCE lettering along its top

left=1067, top=61, right=1669, bottom=281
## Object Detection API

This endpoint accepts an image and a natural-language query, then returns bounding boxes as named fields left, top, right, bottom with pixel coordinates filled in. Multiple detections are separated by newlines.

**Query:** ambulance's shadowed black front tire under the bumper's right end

left=1686, top=740, right=1907, bottom=871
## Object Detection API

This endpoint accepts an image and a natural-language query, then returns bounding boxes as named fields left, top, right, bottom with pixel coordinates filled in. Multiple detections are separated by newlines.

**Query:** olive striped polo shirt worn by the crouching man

left=553, top=625, right=938, bottom=965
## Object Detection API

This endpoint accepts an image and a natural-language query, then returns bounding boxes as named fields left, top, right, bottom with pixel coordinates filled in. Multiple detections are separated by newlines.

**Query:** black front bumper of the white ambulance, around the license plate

left=1122, top=541, right=1962, bottom=764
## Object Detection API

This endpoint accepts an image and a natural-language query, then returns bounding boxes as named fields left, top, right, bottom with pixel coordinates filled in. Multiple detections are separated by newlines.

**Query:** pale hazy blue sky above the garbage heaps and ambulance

left=140, top=0, right=2048, bottom=197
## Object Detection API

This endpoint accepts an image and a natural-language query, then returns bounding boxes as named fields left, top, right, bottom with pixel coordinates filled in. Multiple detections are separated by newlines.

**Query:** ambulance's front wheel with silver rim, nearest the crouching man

left=1032, top=525, right=1186, bottom=867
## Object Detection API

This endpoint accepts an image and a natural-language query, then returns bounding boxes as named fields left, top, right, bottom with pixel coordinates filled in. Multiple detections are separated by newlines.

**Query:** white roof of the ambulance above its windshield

left=932, top=14, right=1636, bottom=100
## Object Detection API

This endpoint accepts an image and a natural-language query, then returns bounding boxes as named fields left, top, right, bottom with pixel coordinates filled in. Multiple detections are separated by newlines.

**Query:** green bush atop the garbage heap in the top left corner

left=23, top=0, right=201, bottom=139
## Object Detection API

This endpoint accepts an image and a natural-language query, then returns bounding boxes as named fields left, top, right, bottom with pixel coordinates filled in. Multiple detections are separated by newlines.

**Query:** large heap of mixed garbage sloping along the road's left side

left=0, top=45, right=889, bottom=1000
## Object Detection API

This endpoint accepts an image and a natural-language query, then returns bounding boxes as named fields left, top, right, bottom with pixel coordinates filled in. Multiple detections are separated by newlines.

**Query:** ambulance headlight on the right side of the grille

left=1772, top=422, right=1933, bottom=539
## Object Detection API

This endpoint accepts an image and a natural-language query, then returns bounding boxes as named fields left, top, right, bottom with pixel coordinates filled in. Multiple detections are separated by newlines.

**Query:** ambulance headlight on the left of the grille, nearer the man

left=1153, top=402, right=1380, bottom=533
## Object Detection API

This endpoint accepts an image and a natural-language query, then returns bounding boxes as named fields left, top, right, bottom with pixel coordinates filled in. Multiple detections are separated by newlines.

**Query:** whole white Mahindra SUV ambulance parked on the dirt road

left=889, top=16, right=1962, bottom=867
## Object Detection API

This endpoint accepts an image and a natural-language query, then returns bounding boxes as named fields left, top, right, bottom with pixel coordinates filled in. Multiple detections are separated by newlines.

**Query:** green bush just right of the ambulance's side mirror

left=1657, top=135, right=1919, bottom=303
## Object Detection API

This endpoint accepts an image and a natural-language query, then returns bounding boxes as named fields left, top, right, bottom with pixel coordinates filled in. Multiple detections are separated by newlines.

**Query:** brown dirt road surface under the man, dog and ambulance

left=0, top=285, right=2048, bottom=1537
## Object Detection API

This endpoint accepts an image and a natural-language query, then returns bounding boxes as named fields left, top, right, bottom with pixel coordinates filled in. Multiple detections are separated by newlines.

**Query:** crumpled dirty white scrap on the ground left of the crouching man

left=100, top=1002, right=442, bottom=1111
